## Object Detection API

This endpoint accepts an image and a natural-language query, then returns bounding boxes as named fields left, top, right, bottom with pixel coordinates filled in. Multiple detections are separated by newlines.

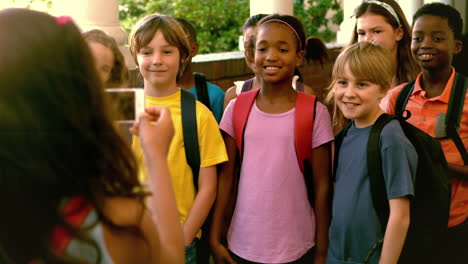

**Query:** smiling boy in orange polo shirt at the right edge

left=386, top=3, right=468, bottom=264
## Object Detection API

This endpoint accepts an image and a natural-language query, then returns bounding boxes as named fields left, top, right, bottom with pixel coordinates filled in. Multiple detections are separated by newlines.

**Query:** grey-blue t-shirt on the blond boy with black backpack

left=327, top=120, right=418, bottom=264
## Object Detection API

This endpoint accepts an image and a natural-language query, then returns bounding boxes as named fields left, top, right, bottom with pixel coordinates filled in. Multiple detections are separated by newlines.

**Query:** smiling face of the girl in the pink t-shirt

left=254, top=22, right=303, bottom=85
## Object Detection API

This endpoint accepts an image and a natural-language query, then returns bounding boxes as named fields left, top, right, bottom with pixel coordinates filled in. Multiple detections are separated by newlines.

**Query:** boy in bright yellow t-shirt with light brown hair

left=129, top=14, right=227, bottom=264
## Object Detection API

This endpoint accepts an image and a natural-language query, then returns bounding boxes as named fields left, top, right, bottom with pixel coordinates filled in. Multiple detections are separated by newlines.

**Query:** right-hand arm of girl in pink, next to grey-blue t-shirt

left=312, top=142, right=331, bottom=264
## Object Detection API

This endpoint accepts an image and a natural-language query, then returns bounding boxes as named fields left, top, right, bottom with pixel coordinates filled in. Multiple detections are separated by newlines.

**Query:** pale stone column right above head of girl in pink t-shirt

left=250, top=0, right=294, bottom=16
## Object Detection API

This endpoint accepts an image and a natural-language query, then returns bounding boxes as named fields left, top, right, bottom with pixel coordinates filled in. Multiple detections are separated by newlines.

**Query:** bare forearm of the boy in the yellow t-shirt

left=183, top=165, right=217, bottom=245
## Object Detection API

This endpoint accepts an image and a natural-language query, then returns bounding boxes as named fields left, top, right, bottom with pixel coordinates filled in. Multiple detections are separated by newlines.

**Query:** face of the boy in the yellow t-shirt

left=137, top=31, right=180, bottom=87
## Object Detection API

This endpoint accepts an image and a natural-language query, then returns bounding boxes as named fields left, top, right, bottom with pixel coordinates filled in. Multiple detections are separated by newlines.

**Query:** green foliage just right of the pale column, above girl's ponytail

left=294, top=0, right=343, bottom=42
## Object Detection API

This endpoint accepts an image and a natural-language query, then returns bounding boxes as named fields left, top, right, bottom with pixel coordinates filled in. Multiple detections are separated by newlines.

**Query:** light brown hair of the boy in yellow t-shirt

left=128, top=14, right=192, bottom=81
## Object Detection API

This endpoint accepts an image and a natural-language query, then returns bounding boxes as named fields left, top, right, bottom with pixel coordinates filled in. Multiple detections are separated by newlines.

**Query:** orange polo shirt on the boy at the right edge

left=386, top=67, right=468, bottom=227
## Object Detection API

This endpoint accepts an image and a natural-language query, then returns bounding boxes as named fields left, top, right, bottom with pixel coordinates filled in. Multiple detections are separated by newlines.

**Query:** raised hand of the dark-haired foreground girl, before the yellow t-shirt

left=130, top=106, right=174, bottom=155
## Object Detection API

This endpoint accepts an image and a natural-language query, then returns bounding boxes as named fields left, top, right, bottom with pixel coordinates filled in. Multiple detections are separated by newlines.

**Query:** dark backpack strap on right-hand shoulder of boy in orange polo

left=445, top=73, right=468, bottom=165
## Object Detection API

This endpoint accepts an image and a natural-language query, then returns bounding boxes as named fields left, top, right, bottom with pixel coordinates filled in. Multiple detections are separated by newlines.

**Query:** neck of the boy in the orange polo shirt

left=420, top=65, right=452, bottom=98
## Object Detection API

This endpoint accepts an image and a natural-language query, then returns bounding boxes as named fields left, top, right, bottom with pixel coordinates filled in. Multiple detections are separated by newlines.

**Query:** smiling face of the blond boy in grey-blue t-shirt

left=334, top=65, right=386, bottom=127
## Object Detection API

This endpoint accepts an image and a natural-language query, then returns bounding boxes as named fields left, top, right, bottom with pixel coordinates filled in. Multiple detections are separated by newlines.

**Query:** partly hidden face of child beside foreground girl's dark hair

left=89, top=42, right=114, bottom=84
